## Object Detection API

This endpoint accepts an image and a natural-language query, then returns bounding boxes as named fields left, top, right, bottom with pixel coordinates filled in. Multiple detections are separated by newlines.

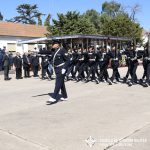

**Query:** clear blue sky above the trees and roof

left=0, top=0, right=150, bottom=30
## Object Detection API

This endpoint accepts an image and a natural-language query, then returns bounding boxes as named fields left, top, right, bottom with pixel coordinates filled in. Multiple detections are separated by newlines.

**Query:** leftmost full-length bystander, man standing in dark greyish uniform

left=2, top=52, right=10, bottom=80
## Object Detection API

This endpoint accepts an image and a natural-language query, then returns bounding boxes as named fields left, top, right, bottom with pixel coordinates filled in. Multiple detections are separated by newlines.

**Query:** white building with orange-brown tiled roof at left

left=0, top=21, right=47, bottom=54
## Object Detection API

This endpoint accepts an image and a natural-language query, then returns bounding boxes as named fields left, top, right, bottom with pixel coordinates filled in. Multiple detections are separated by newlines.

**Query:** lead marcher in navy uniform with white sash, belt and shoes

left=48, top=40, right=69, bottom=103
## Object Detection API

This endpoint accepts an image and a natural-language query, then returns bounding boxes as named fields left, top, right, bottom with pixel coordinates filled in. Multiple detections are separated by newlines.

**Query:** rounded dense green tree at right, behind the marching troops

left=102, top=14, right=142, bottom=40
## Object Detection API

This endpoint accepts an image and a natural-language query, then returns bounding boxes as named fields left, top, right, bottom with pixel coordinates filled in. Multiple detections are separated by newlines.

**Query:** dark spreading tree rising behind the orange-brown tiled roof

left=7, top=4, right=44, bottom=24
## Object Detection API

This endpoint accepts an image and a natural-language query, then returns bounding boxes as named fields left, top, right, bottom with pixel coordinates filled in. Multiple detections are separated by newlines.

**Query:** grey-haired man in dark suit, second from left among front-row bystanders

left=14, top=52, right=23, bottom=79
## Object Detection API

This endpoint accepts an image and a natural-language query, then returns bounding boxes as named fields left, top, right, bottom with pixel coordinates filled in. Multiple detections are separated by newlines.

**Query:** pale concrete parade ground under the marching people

left=0, top=67, right=150, bottom=150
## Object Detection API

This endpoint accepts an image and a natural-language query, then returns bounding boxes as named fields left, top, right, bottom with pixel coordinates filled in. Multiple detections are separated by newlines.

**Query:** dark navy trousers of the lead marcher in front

left=53, top=70, right=68, bottom=99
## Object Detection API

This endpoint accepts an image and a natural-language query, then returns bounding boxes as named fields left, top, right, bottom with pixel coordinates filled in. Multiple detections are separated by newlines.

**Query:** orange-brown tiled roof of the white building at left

left=0, top=21, right=47, bottom=38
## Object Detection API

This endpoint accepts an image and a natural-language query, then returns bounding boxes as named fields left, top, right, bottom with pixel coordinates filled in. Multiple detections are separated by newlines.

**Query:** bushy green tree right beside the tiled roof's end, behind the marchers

left=52, top=11, right=96, bottom=35
